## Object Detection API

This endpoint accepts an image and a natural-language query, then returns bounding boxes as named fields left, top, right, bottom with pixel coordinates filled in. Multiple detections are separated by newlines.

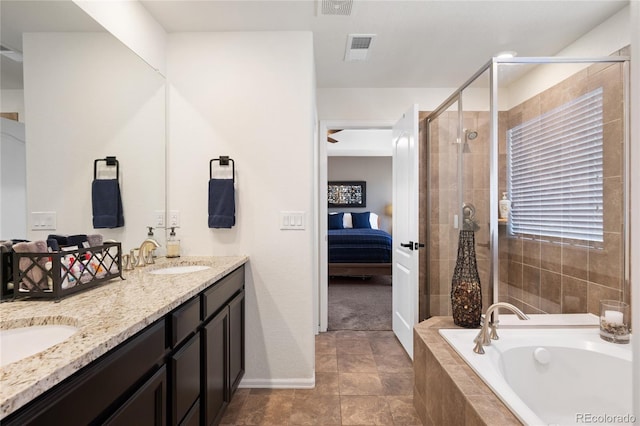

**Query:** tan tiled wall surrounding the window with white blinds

left=499, top=58, right=630, bottom=314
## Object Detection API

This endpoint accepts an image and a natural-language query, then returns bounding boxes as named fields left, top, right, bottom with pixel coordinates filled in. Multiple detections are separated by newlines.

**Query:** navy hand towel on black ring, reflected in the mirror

left=91, top=179, right=124, bottom=228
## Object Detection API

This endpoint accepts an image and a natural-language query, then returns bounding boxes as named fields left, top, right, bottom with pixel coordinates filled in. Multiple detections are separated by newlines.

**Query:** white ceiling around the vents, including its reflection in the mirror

left=0, top=0, right=629, bottom=88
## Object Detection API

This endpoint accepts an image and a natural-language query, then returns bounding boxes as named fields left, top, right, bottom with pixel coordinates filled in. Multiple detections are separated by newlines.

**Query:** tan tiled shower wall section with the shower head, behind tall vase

left=428, top=111, right=493, bottom=316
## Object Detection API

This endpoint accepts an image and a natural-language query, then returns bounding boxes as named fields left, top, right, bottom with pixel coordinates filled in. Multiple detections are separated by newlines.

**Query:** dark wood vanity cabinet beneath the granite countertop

left=1, top=266, right=245, bottom=426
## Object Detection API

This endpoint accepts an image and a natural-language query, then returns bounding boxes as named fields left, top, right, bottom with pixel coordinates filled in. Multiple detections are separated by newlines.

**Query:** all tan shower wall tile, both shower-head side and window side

left=427, top=55, right=630, bottom=316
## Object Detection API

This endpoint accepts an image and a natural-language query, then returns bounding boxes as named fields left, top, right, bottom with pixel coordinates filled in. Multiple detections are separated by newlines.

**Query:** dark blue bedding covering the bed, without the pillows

left=328, top=228, right=391, bottom=263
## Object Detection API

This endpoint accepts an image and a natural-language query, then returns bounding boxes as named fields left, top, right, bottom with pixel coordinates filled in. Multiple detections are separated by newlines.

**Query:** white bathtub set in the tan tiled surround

left=440, top=328, right=636, bottom=425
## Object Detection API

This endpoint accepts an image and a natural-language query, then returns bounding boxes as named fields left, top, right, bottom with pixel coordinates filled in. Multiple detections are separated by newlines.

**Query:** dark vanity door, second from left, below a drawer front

left=170, top=334, right=200, bottom=425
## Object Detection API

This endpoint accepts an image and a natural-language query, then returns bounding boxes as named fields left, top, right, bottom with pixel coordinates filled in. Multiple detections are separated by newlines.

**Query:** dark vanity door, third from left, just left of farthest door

left=201, top=307, right=229, bottom=426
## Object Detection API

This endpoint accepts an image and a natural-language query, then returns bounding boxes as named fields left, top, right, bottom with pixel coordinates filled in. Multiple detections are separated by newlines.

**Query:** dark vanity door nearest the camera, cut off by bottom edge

left=105, top=365, right=167, bottom=426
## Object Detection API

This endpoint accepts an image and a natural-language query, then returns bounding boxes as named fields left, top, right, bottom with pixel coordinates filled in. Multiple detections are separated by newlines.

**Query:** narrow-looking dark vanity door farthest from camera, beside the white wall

left=227, top=290, right=244, bottom=401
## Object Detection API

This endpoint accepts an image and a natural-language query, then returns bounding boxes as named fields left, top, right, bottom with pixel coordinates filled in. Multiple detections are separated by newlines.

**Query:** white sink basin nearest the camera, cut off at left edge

left=0, top=324, right=78, bottom=367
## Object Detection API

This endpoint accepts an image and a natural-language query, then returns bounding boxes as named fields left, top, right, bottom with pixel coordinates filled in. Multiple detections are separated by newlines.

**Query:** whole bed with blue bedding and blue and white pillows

left=328, top=212, right=392, bottom=276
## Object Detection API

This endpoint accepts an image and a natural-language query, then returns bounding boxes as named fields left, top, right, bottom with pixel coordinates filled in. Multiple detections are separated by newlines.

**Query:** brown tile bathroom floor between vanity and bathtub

left=221, top=331, right=422, bottom=426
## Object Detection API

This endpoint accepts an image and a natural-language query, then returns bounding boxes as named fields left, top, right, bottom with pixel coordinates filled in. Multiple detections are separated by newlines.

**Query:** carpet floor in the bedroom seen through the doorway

left=328, top=276, right=391, bottom=331
